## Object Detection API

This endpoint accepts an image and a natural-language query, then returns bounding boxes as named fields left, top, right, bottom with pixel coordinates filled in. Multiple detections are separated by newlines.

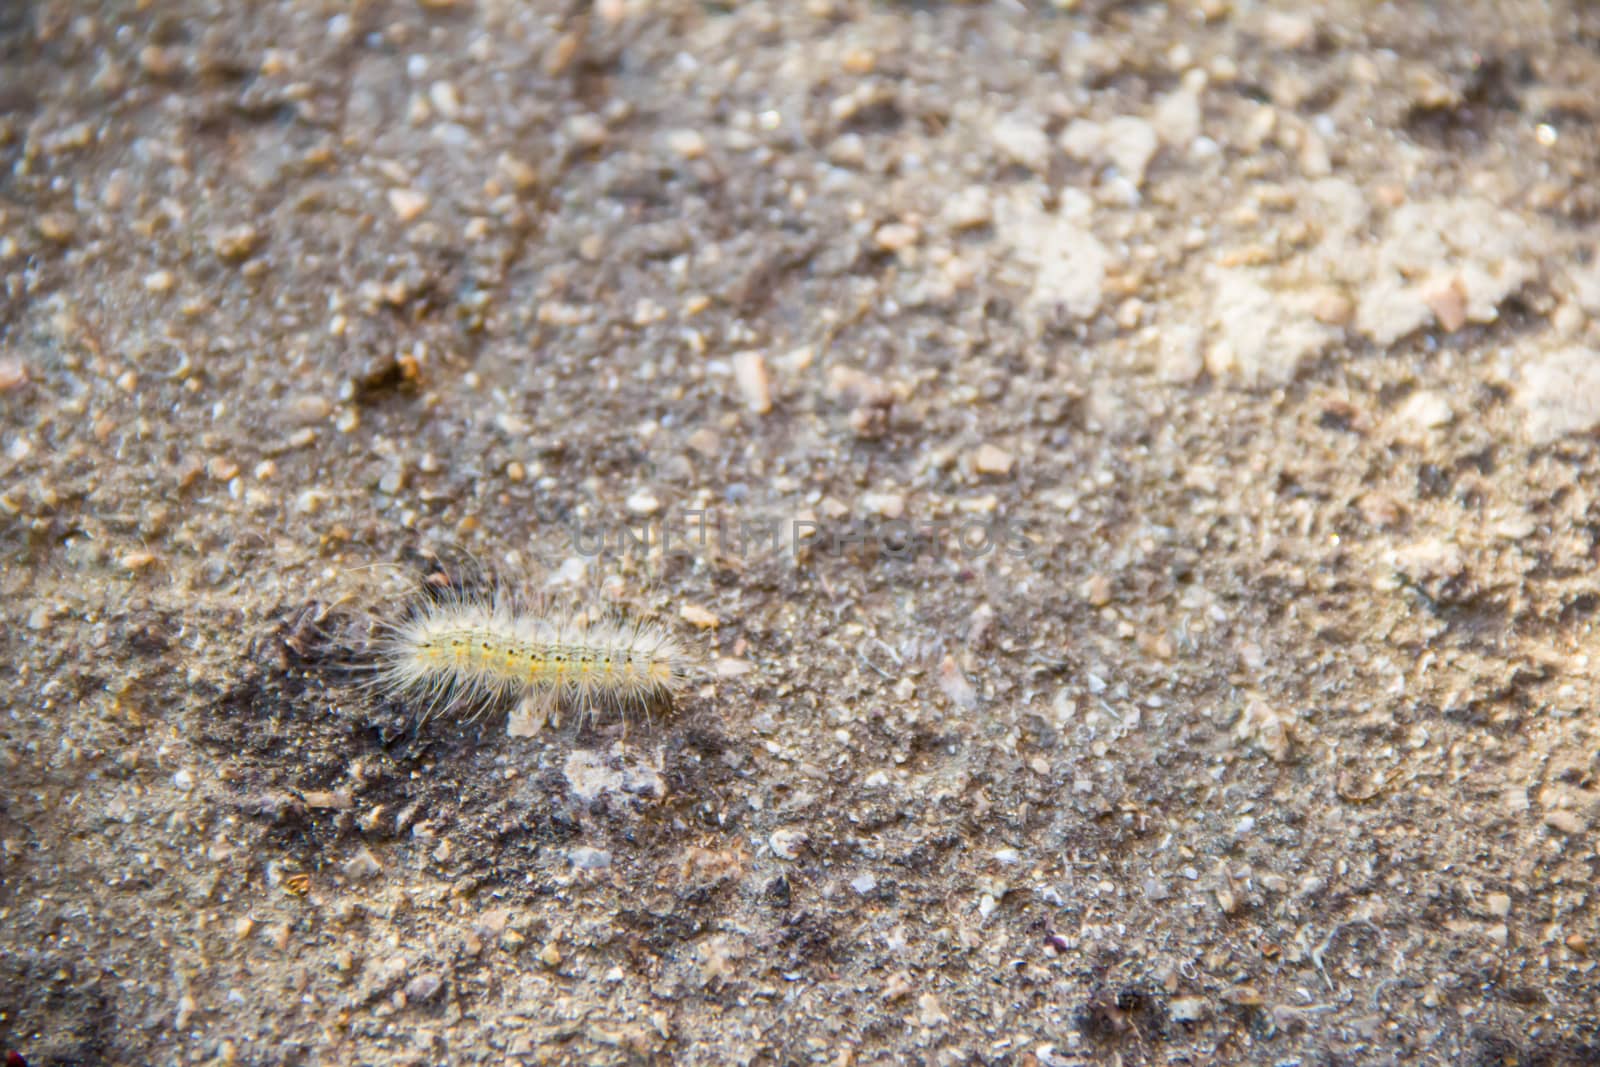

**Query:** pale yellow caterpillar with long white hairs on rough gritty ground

left=370, top=587, right=694, bottom=734
